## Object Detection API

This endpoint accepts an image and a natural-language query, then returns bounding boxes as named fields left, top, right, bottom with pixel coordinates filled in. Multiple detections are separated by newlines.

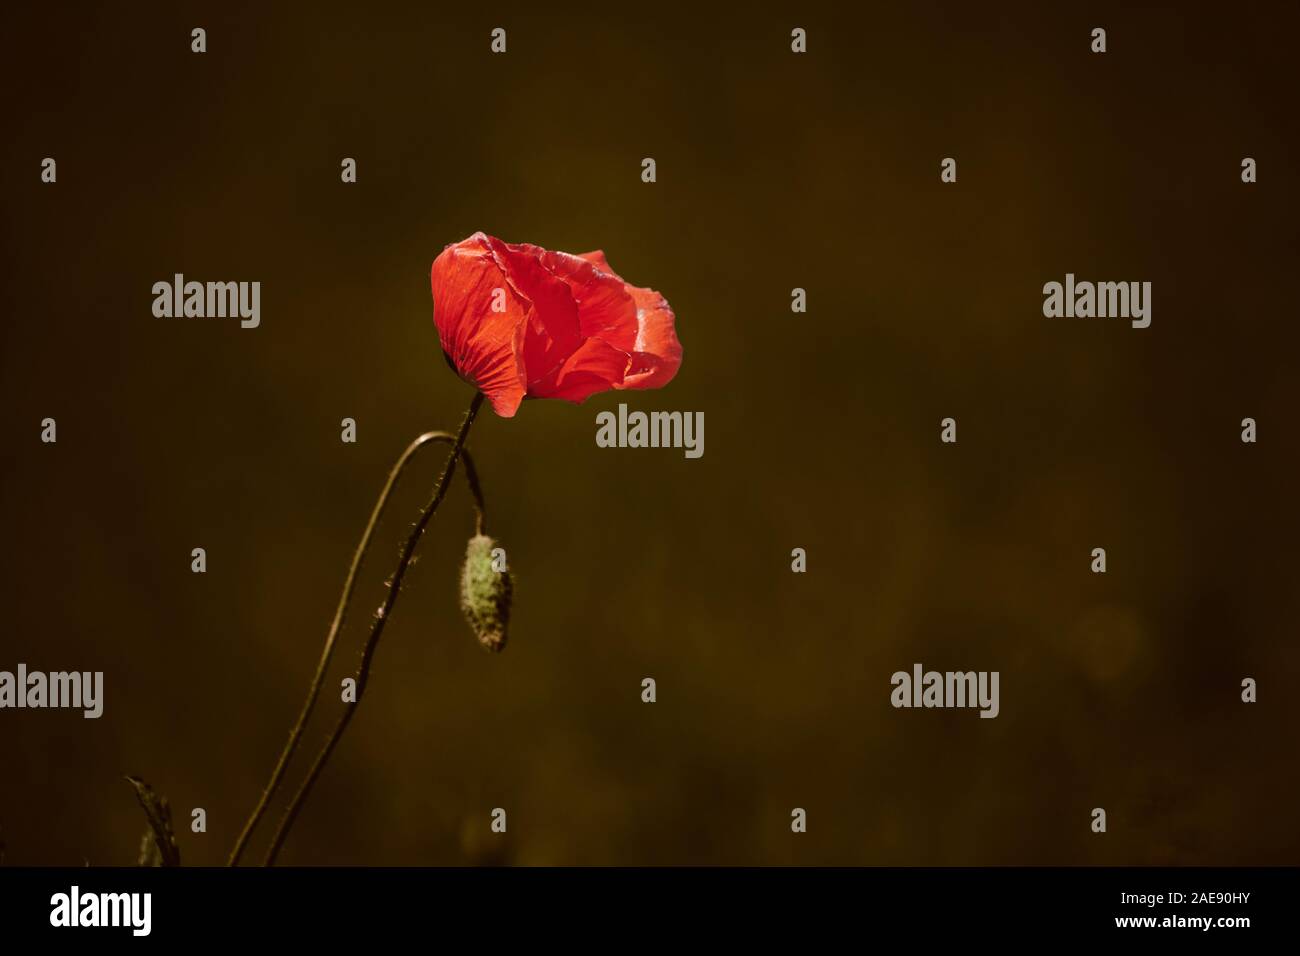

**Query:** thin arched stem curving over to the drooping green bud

left=226, top=395, right=486, bottom=866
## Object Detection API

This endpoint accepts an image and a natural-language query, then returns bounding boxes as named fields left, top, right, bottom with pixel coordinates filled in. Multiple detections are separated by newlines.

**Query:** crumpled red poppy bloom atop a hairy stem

left=429, top=233, right=681, bottom=418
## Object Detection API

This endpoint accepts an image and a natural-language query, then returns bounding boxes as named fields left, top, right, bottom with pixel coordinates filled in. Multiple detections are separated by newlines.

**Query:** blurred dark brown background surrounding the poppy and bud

left=0, top=3, right=1300, bottom=865
